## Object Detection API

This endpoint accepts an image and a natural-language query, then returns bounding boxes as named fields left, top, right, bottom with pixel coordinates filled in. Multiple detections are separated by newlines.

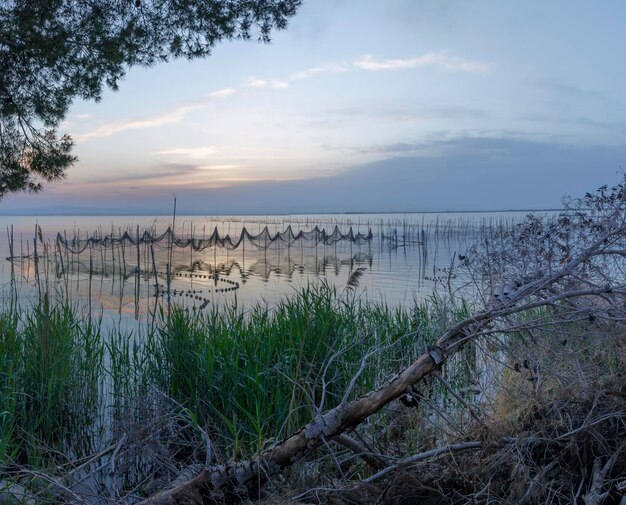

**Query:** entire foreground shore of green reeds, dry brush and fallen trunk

left=0, top=181, right=626, bottom=505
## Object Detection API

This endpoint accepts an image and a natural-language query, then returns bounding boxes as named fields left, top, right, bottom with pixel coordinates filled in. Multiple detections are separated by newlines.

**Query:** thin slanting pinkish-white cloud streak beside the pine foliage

left=74, top=88, right=235, bottom=141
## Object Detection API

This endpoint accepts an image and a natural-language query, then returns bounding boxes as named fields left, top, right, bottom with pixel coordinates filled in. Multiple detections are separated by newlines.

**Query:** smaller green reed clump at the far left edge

left=0, top=296, right=103, bottom=464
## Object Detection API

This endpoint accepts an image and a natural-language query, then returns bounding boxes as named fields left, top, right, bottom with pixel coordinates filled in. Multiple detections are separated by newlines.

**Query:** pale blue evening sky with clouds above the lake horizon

left=0, top=0, right=626, bottom=214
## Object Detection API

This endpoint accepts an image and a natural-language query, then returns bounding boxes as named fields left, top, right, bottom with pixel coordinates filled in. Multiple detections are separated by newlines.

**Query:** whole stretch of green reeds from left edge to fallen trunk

left=0, top=283, right=470, bottom=465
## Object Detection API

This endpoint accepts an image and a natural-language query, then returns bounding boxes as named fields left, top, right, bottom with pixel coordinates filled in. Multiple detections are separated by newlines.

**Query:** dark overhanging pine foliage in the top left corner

left=0, top=0, right=301, bottom=197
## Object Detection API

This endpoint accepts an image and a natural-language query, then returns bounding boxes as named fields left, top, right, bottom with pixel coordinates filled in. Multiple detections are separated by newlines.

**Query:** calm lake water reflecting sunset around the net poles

left=0, top=212, right=527, bottom=321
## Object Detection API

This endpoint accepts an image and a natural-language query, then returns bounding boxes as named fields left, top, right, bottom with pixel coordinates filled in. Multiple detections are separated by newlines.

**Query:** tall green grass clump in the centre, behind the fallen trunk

left=140, top=284, right=446, bottom=457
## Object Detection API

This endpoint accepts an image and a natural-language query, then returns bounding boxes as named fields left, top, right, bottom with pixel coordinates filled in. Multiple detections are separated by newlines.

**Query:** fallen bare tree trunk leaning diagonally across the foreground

left=141, top=182, right=626, bottom=505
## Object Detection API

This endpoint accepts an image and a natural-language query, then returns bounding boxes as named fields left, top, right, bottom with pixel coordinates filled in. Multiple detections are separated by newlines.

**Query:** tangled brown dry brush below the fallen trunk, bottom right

left=319, top=323, right=626, bottom=505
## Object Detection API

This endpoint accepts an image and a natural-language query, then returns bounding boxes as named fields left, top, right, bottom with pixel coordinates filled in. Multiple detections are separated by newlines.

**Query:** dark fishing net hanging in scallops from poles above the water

left=56, top=226, right=372, bottom=254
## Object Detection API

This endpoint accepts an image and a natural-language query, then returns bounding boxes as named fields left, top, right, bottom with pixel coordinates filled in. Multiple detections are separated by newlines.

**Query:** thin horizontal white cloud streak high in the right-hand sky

left=352, top=53, right=490, bottom=74
